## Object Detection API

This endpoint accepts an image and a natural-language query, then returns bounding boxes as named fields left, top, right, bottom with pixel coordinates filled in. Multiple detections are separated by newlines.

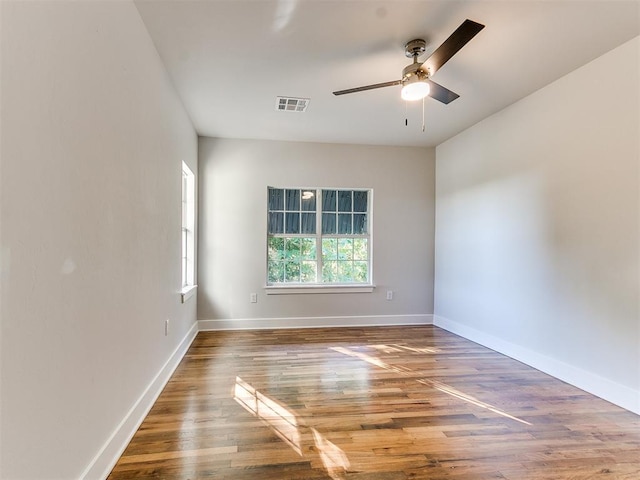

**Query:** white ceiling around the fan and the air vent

left=135, top=0, right=640, bottom=146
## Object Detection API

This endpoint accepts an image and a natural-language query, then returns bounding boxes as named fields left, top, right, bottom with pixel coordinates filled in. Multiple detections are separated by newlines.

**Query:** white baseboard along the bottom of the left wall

left=80, top=322, right=198, bottom=480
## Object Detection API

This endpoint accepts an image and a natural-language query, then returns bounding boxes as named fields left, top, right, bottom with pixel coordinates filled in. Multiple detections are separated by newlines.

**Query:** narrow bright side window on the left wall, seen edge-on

left=182, top=162, right=196, bottom=302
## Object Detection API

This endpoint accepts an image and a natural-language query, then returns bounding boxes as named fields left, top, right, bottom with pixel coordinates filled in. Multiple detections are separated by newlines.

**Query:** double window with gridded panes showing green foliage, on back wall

left=267, top=187, right=371, bottom=286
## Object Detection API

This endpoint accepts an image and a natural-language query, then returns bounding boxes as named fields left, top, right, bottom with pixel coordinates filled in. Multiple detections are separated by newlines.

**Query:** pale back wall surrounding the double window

left=198, top=138, right=434, bottom=328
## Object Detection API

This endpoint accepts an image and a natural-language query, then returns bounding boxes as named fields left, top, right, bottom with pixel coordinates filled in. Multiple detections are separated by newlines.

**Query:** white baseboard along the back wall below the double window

left=198, top=314, right=433, bottom=332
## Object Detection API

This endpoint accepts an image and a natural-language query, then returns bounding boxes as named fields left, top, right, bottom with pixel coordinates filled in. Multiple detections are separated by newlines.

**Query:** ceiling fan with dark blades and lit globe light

left=333, top=20, right=484, bottom=104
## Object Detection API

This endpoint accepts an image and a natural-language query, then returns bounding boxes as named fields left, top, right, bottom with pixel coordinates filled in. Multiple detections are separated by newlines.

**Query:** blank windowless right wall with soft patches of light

left=435, top=38, right=640, bottom=412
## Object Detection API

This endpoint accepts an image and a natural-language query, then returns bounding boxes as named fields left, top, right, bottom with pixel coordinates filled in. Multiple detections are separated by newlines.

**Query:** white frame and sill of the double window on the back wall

left=264, top=185, right=375, bottom=295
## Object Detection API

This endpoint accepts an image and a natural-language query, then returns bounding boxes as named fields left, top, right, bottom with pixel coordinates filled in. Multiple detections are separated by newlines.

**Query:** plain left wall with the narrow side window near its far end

left=0, top=1, right=197, bottom=480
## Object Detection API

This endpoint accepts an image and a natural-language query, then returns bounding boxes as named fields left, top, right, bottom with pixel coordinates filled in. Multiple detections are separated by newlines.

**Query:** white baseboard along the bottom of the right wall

left=433, top=315, right=640, bottom=415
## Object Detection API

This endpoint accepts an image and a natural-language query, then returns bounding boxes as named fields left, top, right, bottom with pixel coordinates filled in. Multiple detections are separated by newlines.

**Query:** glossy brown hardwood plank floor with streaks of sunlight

left=109, top=326, right=640, bottom=480
